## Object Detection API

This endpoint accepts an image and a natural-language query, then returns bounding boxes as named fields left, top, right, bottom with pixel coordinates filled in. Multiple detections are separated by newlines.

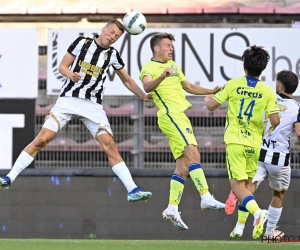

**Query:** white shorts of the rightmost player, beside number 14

left=252, top=161, right=291, bottom=191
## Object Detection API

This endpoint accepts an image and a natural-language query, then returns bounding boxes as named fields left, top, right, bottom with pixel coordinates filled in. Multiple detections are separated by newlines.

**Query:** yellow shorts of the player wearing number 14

left=226, top=144, right=260, bottom=181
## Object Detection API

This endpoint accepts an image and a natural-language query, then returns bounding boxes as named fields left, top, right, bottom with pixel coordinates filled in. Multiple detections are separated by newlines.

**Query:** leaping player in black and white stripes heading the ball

left=0, top=20, right=152, bottom=201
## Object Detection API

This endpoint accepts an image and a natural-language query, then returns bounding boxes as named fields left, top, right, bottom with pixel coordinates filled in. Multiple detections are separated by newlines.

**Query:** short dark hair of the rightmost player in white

left=276, top=70, right=299, bottom=94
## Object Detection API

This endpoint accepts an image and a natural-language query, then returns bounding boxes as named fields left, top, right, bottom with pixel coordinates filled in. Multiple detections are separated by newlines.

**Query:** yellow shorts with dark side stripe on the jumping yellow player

left=157, top=112, right=198, bottom=160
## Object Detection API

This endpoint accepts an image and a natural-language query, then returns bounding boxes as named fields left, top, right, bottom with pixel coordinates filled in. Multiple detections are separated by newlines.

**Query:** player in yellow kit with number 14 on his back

left=204, top=45, right=280, bottom=239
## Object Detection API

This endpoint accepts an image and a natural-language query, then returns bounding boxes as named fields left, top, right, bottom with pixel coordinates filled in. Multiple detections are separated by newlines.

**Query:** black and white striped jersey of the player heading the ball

left=59, top=36, right=124, bottom=104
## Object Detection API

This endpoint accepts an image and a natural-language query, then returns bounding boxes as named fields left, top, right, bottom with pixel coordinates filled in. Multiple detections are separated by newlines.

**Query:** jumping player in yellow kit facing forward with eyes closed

left=140, top=33, right=225, bottom=230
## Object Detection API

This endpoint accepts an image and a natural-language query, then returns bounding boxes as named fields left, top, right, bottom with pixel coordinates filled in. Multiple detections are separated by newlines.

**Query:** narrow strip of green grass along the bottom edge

left=0, top=239, right=300, bottom=250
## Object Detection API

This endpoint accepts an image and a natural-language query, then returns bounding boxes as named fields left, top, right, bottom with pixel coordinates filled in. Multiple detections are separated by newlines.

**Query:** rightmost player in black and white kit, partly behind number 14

left=231, top=70, right=300, bottom=242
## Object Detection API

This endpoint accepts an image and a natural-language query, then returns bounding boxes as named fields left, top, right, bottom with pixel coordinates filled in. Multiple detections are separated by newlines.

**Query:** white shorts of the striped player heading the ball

left=43, top=97, right=113, bottom=138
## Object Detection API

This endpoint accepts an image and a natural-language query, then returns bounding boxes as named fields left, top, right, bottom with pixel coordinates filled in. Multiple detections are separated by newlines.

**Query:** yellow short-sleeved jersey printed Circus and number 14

left=214, top=76, right=279, bottom=148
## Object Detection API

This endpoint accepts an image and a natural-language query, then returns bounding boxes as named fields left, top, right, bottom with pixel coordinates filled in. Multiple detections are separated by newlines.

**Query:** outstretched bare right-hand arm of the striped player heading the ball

left=116, top=68, right=152, bottom=102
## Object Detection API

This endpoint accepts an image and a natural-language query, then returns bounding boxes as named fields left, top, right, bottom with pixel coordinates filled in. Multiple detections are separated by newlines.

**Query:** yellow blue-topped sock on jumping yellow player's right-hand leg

left=189, top=163, right=211, bottom=196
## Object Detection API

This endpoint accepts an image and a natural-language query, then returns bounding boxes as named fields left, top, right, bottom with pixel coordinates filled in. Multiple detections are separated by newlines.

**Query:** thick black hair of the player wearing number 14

left=242, top=45, right=270, bottom=77
